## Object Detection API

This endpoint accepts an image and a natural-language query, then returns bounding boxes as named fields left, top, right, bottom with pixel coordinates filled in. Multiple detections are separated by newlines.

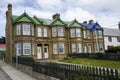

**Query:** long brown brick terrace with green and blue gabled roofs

left=6, top=4, right=104, bottom=62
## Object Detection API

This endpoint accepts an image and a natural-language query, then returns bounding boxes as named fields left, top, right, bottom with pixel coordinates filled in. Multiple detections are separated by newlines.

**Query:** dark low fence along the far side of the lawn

left=68, top=53, right=120, bottom=61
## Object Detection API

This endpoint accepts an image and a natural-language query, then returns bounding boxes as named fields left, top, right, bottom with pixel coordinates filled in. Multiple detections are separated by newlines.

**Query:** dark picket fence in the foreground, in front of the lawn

left=32, top=62, right=120, bottom=80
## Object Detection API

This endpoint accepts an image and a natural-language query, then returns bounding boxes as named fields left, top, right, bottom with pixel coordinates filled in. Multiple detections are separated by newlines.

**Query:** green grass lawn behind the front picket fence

left=60, top=58, right=120, bottom=70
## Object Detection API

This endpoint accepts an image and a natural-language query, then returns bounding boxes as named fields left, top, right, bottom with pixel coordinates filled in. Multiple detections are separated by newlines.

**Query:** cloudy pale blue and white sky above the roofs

left=0, top=0, right=120, bottom=36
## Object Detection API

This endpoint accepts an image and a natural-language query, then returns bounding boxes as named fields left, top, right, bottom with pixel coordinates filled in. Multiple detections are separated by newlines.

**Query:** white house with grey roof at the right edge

left=103, top=23, right=120, bottom=50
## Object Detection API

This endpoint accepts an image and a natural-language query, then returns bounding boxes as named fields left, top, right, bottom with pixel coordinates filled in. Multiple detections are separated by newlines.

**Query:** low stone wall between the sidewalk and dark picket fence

left=13, top=64, right=60, bottom=80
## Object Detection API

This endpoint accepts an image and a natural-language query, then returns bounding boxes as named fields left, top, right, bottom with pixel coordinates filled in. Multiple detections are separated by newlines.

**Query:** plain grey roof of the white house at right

left=103, top=28, right=120, bottom=36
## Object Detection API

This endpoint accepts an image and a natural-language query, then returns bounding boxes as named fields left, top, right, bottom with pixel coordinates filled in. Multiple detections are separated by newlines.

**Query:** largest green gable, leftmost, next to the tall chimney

left=13, top=12, right=37, bottom=24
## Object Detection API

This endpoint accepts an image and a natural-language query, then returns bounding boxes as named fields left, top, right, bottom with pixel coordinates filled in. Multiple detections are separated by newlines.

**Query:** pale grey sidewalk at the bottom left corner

left=0, top=60, right=37, bottom=80
